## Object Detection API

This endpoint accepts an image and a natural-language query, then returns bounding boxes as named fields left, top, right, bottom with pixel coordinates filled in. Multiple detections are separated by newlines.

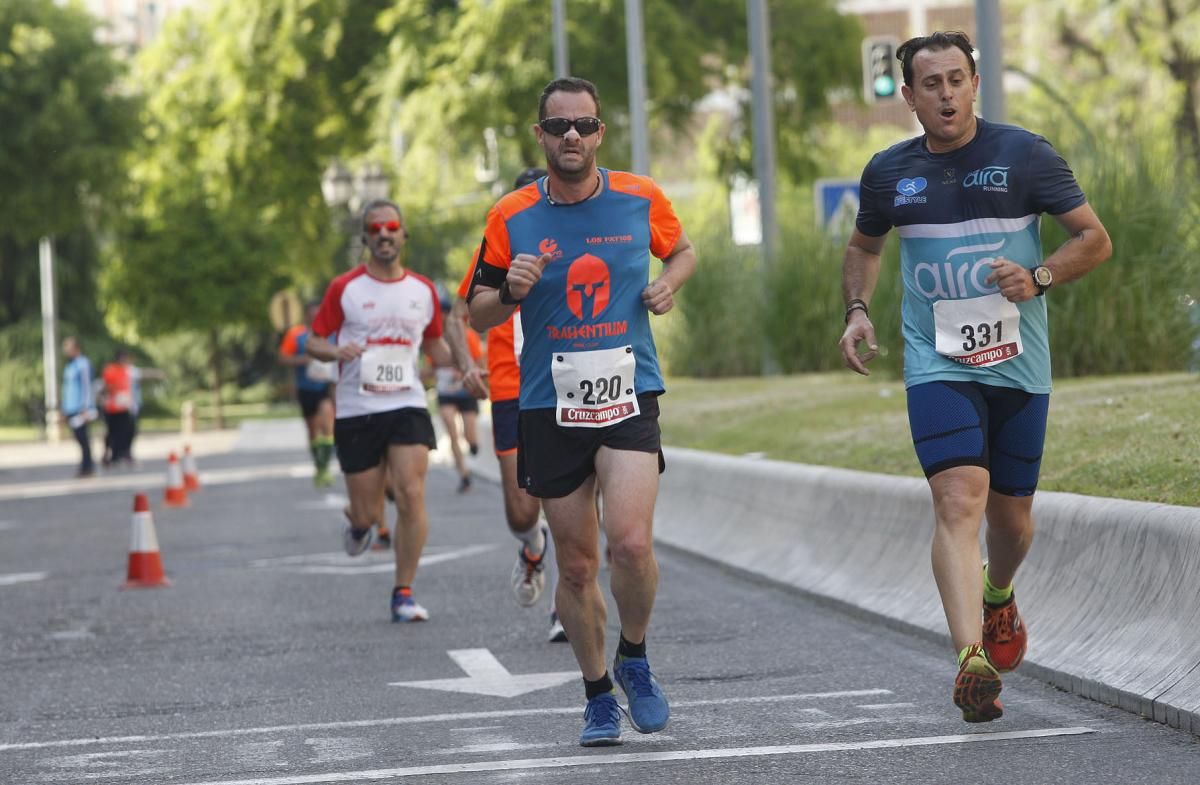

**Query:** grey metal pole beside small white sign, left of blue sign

left=746, top=0, right=779, bottom=373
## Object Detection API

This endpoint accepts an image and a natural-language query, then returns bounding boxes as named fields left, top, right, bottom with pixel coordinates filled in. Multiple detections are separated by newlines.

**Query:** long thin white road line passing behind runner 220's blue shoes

left=0, top=689, right=893, bottom=753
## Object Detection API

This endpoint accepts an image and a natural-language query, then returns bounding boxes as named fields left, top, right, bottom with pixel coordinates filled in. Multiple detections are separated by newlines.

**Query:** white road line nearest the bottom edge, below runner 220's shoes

left=169, top=727, right=1096, bottom=785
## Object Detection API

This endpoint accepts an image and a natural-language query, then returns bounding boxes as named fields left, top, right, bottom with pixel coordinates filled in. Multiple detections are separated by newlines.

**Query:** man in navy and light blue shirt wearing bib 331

left=841, top=32, right=1112, bottom=723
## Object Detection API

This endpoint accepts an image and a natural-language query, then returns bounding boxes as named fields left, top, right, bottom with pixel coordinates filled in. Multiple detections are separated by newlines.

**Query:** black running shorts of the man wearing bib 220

left=517, top=393, right=666, bottom=499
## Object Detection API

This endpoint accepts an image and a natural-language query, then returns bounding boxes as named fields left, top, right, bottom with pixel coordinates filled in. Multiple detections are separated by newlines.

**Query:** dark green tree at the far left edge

left=0, top=0, right=137, bottom=325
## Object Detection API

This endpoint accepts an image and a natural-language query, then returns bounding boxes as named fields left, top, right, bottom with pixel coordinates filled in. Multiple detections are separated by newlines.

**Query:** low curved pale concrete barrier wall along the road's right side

left=655, top=449, right=1200, bottom=733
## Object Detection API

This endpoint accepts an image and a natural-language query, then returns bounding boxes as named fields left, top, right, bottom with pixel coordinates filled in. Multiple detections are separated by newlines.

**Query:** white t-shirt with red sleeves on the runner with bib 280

left=312, top=264, right=442, bottom=420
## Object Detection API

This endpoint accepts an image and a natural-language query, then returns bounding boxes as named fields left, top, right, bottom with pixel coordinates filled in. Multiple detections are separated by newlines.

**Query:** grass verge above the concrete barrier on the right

left=661, top=371, right=1200, bottom=507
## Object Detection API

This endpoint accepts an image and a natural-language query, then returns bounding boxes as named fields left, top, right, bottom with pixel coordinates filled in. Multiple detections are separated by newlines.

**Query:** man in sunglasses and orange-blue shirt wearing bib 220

left=468, top=78, right=696, bottom=747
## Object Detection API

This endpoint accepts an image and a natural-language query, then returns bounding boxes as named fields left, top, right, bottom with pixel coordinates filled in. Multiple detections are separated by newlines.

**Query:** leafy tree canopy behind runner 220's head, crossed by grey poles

left=376, top=0, right=859, bottom=206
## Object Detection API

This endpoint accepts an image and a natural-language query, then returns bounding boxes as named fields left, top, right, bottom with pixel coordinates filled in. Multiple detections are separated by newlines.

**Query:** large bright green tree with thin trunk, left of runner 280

left=103, top=0, right=385, bottom=425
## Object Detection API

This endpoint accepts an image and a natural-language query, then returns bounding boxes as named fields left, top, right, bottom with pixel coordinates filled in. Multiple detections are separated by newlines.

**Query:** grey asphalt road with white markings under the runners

left=0, top=450, right=1200, bottom=785
